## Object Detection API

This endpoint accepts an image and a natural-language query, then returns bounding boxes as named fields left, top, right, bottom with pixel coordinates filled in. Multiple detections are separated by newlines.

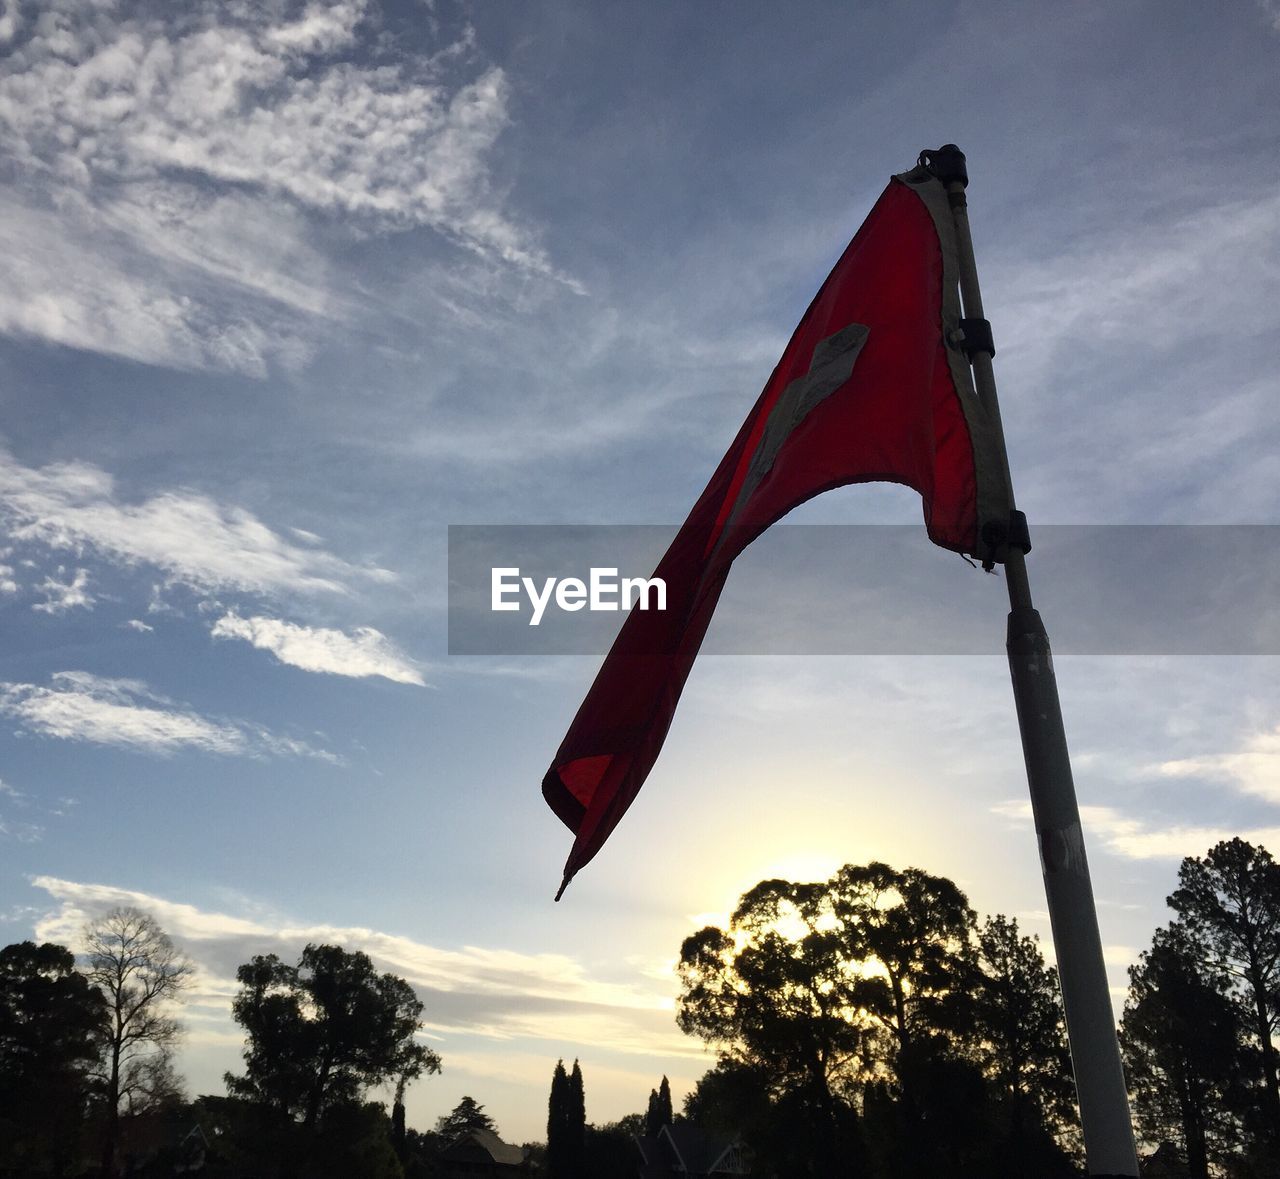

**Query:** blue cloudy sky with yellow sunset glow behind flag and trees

left=0, top=0, right=1280, bottom=1142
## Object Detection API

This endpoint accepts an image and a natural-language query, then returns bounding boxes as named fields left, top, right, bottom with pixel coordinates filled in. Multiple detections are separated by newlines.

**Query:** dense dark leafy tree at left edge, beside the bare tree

left=0, top=941, right=106, bottom=1175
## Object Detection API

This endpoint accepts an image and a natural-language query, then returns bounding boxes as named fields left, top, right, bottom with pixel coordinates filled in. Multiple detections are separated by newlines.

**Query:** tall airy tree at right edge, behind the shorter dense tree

left=1169, top=838, right=1280, bottom=1152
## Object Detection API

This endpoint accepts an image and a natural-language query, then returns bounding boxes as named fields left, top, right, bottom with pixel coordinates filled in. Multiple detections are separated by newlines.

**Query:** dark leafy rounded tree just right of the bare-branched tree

left=227, top=945, right=440, bottom=1132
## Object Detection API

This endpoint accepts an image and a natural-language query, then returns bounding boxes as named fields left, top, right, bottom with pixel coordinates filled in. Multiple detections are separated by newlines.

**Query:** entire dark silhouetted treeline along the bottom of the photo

left=0, top=838, right=1280, bottom=1179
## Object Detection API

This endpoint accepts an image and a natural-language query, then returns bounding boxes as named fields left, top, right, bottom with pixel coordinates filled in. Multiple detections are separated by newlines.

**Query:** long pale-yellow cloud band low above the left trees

left=24, top=876, right=701, bottom=1063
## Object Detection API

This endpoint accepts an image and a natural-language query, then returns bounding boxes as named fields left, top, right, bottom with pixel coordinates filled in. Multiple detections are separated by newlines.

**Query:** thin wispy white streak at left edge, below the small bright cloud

left=0, top=671, right=338, bottom=762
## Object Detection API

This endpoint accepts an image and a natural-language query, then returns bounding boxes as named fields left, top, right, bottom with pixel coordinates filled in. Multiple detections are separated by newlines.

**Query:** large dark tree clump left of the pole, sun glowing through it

left=677, top=863, right=1071, bottom=1179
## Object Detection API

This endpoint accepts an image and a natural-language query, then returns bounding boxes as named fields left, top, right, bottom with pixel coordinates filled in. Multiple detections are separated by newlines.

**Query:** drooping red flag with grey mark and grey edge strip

left=543, top=166, right=1009, bottom=900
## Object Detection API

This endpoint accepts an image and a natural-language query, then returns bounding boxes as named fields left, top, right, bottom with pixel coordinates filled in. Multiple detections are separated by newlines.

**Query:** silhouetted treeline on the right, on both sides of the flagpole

left=677, top=838, right=1280, bottom=1179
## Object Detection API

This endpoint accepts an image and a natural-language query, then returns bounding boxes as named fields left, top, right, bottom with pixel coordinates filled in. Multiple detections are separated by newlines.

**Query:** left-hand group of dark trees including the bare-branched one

left=0, top=909, right=437, bottom=1179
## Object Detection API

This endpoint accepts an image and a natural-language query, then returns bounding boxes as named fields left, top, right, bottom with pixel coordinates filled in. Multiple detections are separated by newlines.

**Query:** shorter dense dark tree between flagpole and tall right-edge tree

left=1120, top=923, right=1242, bottom=1179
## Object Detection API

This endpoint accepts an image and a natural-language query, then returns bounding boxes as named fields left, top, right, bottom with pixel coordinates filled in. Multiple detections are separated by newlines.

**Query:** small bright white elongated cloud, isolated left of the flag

left=210, top=613, right=426, bottom=687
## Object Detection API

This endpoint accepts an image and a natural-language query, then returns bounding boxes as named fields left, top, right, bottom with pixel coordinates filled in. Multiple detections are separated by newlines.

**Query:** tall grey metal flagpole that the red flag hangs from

left=928, top=145, right=1138, bottom=1176
